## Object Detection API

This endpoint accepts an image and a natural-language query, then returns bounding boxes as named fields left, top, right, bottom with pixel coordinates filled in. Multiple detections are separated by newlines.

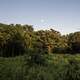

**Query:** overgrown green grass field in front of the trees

left=0, top=54, right=80, bottom=80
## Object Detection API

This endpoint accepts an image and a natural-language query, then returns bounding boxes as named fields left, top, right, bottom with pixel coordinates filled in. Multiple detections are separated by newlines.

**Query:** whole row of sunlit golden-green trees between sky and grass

left=0, top=23, right=80, bottom=57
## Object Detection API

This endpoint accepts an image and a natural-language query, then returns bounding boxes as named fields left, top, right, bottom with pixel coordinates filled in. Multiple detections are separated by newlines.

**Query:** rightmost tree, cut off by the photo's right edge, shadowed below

left=68, top=32, right=80, bottom=53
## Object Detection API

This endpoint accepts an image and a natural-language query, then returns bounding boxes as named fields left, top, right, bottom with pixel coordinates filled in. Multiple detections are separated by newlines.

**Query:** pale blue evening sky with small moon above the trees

left=0, top=0, right=80, bottom=34
